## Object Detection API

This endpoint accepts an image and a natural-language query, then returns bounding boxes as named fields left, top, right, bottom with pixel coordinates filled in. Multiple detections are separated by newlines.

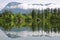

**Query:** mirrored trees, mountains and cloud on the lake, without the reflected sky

left=0, top=21, right=60, bottom=38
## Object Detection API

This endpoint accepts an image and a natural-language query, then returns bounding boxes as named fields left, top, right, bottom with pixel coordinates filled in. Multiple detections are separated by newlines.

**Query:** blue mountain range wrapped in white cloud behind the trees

left=2, top=2, right=54, bottom=13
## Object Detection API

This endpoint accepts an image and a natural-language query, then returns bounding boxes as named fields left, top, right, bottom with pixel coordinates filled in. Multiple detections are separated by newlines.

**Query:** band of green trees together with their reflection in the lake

left=0, top=8, right=60, bottom=32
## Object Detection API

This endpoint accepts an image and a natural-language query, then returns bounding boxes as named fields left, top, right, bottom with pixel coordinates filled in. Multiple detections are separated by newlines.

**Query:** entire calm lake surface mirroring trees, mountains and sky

left=0, top=22, right=60, bottom=40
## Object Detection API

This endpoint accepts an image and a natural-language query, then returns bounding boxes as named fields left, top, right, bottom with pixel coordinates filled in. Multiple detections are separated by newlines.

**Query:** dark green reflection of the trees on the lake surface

left=0, top=21, right=60, bottom=32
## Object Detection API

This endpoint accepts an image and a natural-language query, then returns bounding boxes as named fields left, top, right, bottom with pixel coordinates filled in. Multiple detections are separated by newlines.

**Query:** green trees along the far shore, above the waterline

left=0, top=8, right=60, bottom=22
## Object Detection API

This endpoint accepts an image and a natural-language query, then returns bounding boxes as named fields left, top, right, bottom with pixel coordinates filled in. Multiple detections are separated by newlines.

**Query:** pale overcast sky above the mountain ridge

left=0, top=0, right=60, bottom=10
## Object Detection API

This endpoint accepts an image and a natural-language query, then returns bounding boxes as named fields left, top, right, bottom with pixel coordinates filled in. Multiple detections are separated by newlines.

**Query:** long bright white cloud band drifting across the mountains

left=7, top=3, right=56, bottom=9
